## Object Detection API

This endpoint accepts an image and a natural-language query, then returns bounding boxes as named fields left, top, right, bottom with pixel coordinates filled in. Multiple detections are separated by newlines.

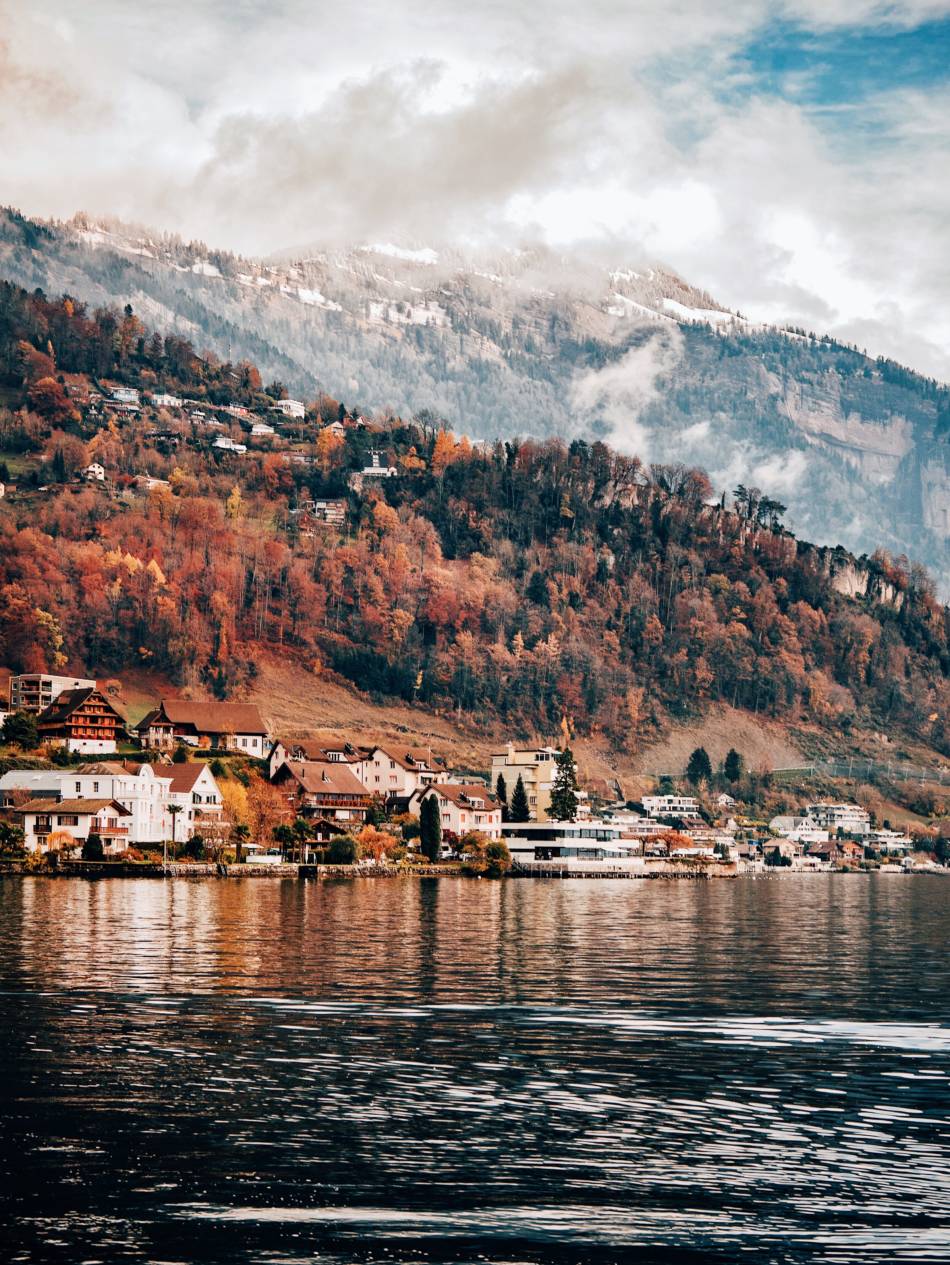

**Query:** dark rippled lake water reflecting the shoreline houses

left=0, top=875, right=950, bottom=1265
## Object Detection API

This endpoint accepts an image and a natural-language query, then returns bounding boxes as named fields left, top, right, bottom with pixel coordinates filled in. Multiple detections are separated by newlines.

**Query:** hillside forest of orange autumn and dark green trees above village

left=0, top=283, right=950, bottom=750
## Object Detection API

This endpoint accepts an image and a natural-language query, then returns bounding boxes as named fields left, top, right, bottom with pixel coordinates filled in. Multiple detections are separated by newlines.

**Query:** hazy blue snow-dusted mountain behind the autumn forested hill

left=0, top=202, right=950, bottom=592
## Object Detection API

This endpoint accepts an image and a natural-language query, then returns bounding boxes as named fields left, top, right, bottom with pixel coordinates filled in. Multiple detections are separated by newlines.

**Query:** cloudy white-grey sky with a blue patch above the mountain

left=0, top=0, right=950, bottom=378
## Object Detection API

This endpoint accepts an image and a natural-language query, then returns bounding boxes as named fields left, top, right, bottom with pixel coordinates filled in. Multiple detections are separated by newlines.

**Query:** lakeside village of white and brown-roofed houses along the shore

left=0, top=673, right=942, bottom=877
